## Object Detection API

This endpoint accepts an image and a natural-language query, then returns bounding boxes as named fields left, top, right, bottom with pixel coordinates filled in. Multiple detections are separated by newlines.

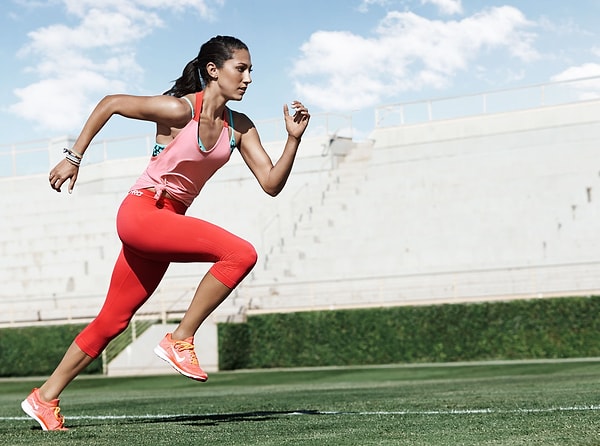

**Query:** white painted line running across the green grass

left=0, top=405, right=600, bottom=421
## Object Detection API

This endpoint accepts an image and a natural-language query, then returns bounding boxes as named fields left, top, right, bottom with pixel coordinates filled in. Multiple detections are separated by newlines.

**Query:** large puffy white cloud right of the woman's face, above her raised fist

left=293, top=6, right=539, bottom=111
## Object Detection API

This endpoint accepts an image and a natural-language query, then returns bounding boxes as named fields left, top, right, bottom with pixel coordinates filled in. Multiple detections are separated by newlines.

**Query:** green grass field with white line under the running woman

left=0, top=360, right=600, bottom=446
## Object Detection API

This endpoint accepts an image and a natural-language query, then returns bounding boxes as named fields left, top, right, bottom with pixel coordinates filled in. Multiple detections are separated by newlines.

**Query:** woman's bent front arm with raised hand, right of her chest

left=239, top=101, right=310, bottom=197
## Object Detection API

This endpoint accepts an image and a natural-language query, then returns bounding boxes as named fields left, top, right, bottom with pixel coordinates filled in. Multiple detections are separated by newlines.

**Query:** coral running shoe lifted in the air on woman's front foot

left=154, top=333, right=208, bottom=382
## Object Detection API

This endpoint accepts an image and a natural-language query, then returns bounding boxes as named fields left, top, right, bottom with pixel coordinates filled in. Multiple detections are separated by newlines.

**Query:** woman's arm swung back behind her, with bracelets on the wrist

left=49, top=94, right=195, bottom=193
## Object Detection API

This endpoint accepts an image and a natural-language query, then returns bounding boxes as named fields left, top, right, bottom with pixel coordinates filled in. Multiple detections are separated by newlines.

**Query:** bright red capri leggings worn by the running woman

left=75, top=190, right=257, bottom=358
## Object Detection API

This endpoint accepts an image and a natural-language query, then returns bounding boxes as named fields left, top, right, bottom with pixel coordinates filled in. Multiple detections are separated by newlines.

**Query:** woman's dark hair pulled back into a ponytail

left=163, top=36, right=248, bottom=98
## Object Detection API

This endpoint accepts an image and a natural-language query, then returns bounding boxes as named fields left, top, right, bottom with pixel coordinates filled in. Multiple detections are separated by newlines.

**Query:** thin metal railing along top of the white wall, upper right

left=375, top=76, right=600, bottom=128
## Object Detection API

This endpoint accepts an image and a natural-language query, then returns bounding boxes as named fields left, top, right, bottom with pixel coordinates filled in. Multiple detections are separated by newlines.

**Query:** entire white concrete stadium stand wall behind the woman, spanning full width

left=0, top=101, right=600, bottom=323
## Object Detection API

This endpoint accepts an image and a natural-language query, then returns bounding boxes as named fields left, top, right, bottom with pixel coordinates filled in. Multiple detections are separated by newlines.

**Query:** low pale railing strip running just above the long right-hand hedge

left=240, top=261, right=600, bottom=314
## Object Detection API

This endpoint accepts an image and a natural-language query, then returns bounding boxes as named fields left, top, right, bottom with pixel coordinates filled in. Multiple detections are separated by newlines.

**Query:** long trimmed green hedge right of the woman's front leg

left=219, top=296, right=600, bottom=370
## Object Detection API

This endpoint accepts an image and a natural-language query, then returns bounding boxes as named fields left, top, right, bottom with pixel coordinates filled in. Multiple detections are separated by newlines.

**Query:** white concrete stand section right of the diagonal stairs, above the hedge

left=237, top=101, right=600, bottom=311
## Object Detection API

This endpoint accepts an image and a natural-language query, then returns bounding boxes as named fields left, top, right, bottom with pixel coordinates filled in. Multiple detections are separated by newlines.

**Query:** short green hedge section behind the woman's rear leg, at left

left=0, top=325, right=102, bottom=376
